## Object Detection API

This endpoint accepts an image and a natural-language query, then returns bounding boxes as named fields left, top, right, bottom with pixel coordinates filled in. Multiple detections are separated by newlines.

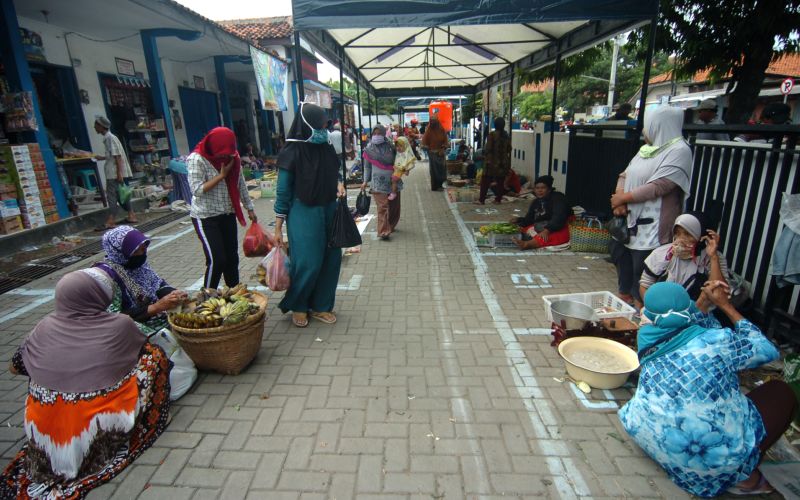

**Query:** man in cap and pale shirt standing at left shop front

left=94, top=116, right=139, bottom=229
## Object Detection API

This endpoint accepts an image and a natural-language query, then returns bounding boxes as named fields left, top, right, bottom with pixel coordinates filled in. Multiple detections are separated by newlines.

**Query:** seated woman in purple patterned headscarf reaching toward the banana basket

left=95, top=226, right=187, bottom=335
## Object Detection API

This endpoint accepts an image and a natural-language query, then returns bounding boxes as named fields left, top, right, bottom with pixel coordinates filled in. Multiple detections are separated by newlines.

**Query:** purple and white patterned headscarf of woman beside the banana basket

left=98, top=226, right=164, bottom=310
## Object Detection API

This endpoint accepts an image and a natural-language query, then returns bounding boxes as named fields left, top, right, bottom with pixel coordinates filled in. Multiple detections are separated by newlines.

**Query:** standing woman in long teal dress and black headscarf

left=275, top=103, right=347, bottom=328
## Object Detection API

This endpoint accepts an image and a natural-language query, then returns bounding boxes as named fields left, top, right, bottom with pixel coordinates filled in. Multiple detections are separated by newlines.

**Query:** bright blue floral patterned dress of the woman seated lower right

left=619, top=311, right=778, bottom=497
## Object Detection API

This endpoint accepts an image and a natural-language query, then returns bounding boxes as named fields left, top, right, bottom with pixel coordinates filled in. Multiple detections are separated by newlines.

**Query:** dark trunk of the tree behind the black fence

left=725, top=0, right=784, bottom=124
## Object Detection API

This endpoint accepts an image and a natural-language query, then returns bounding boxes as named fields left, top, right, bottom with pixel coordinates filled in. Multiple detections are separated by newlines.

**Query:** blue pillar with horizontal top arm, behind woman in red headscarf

left=140, top=28, right=202, bottom=158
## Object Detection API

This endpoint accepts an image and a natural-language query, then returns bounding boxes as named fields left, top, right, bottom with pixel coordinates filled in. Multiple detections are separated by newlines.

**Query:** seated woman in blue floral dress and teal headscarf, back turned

left=619, top=282, right=797, bottom=497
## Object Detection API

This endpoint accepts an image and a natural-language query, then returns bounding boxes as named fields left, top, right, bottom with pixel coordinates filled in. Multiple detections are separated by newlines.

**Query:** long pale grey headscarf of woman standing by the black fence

left=625, top=105, right=692, bottom=227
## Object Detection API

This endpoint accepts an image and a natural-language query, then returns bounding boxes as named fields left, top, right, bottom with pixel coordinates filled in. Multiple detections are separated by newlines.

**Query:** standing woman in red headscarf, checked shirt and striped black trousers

left=186, top=127, right=256, bottom=288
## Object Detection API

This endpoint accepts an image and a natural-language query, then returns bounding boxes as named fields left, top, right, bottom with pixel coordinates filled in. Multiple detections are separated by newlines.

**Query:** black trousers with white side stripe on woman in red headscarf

left=192, top=214, right=239, bottom=288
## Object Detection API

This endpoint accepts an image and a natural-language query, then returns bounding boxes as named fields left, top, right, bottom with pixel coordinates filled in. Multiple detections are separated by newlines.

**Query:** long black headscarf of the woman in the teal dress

left=277, top=102, right=340, bottom=205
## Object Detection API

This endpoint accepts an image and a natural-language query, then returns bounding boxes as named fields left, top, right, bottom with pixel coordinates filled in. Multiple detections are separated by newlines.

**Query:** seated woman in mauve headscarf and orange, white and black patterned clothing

left=0, top=268, right=170, bottom=498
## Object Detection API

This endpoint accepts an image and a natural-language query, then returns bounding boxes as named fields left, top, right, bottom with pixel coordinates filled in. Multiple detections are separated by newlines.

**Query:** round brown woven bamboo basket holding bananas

left=169, top=292, right=267, bottom=375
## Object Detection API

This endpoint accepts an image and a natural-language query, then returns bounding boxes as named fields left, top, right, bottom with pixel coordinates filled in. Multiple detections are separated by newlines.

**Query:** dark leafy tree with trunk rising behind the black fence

left=630, top=0, right=800, bottom=123
